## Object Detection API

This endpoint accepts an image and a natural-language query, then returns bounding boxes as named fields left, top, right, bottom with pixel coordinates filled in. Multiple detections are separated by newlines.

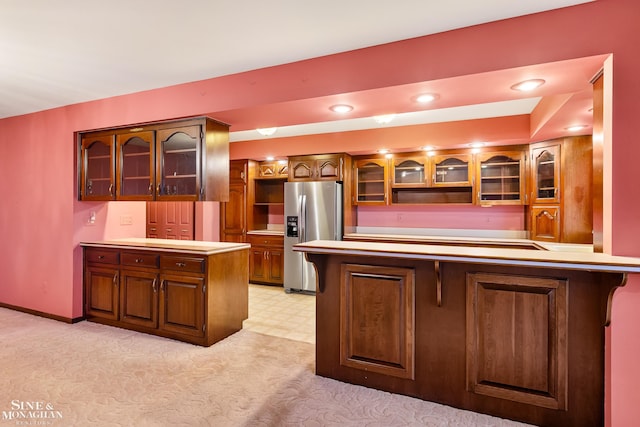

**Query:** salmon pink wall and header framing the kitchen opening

left=0, top=0, right=640, bottom=427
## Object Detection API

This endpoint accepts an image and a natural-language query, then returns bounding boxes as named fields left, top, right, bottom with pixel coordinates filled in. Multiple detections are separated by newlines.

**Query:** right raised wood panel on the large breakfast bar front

left=467, top=273, right=568, bottom=409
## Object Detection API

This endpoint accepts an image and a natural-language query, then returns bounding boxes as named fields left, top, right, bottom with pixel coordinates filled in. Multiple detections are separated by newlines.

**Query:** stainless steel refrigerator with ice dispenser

left=284, top=181, right=342, bottom=293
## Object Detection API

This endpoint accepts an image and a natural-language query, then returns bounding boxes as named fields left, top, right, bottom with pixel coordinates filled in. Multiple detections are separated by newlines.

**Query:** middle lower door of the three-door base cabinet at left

left=120, top=270, right=158, bottom=328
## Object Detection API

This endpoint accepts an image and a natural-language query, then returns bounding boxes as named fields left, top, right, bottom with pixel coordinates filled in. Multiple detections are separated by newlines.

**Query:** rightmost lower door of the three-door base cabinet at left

left=159, top=274, right=205, bottom=337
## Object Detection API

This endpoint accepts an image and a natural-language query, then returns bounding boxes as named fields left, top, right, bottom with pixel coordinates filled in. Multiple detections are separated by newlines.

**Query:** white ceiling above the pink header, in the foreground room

left=0, top=0, right=592, bottom=122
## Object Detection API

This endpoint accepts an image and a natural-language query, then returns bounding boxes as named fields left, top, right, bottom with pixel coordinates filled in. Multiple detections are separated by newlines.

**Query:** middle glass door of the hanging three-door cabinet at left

left=116, top=131, right=155, bottom=200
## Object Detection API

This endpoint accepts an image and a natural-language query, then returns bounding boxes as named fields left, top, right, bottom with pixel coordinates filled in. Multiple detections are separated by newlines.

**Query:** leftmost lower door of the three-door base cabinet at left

left=85, top=266, right=120, bottom=320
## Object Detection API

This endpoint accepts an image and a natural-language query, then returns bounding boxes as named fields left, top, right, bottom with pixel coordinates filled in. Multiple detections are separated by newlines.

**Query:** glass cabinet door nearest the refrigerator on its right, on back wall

left=355, top=159, right=388, bottom=205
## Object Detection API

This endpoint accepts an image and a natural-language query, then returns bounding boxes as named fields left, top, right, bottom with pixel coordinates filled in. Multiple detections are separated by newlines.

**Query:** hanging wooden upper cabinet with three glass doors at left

left=78, top=117, right=229, bottom=201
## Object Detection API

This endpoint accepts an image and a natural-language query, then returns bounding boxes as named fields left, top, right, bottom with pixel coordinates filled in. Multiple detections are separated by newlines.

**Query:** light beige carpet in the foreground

left=0, top=308, right=524, bottom=427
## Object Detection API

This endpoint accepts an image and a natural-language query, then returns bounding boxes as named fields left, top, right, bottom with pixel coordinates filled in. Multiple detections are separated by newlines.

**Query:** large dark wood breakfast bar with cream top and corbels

left=294, top=241, right=640, bottom=426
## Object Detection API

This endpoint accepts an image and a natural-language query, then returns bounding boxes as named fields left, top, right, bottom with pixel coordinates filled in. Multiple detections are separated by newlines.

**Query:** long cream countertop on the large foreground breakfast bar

left=293, top=240, right=640, bottom=273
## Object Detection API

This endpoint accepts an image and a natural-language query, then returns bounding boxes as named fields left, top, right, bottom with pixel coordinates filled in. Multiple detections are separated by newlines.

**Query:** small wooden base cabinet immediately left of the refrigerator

left=248, top=234, right=284, bottom=286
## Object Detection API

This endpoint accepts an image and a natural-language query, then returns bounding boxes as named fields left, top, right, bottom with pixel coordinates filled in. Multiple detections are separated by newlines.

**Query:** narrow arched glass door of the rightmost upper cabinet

left=531, top=145, right=560, bottom=203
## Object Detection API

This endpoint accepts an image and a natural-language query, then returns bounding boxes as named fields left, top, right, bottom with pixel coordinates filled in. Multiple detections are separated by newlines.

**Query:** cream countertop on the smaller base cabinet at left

left=80, top=237, right=251, bottom=255
